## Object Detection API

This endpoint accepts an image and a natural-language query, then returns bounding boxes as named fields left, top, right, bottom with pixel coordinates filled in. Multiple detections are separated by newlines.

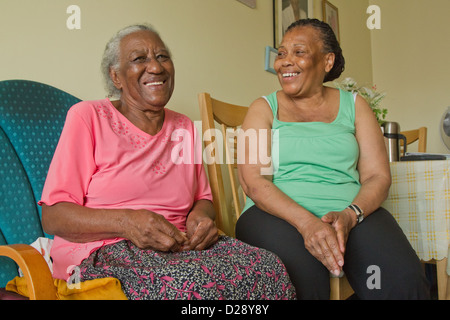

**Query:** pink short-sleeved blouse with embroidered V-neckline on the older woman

left=39, top=99, right=212, bottom=280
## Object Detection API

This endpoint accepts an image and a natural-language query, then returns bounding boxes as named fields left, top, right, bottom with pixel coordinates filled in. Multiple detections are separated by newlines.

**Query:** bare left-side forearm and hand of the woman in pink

left=42, top=202, right=187, bottom=251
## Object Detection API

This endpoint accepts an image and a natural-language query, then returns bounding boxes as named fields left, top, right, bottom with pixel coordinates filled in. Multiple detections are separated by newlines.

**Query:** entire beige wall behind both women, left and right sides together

left=4, top=0, right=450, bottom=152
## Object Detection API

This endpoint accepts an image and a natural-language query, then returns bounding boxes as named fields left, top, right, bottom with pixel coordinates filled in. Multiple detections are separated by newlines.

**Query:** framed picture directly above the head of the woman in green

left=273, top=0, right=314, bottom=48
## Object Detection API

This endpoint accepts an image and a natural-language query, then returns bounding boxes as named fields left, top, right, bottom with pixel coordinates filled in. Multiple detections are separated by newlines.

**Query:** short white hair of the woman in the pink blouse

left=101, top=24, right=159, bottom=98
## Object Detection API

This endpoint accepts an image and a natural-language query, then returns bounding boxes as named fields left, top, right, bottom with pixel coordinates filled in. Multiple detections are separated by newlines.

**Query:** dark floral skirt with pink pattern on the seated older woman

left=79, top=236, right=296, bottom=300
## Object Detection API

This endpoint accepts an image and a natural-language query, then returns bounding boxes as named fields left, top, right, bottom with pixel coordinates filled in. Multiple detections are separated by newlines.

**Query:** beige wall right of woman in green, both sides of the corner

left=315, top=0, right=450, bottom=153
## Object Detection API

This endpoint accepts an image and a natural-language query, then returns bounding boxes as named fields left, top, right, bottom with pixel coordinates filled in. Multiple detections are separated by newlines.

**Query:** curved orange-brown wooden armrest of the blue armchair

left=0, top=244, right=57, bottom=300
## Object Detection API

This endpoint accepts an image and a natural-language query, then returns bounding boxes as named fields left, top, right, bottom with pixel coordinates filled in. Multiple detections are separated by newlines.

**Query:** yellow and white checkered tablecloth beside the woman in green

left=382, top=160, right=450, bottom=274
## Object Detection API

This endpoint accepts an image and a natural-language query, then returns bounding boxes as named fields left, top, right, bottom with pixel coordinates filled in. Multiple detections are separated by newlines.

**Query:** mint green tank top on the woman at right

left=242, top=90, right=361, bottom=217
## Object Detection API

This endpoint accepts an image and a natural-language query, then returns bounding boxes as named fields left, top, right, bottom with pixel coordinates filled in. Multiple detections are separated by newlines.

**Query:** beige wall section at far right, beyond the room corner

left=370, top=0, right=450, bottom=153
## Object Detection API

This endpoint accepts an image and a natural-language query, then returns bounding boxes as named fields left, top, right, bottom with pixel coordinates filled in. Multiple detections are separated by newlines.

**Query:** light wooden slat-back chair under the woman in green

left=198, top=93, right=353, bottom=300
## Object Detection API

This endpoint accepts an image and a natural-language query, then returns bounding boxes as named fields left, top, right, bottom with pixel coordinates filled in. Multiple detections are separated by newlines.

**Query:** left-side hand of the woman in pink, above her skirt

left=126, top=210, right=187, bottom=252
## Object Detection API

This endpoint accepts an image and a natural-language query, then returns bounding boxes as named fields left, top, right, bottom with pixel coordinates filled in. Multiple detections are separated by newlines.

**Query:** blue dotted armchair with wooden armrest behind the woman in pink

left=0, top=80, right=80, bottom=299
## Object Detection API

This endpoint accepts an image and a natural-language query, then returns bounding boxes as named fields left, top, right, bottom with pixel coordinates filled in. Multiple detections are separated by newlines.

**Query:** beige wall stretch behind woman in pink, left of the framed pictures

left=0, top=0, right=278, bottom=120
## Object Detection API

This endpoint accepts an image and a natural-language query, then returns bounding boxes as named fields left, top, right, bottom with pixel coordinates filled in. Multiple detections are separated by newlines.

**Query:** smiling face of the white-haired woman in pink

left=111, top=31, right=175, bottom=111
